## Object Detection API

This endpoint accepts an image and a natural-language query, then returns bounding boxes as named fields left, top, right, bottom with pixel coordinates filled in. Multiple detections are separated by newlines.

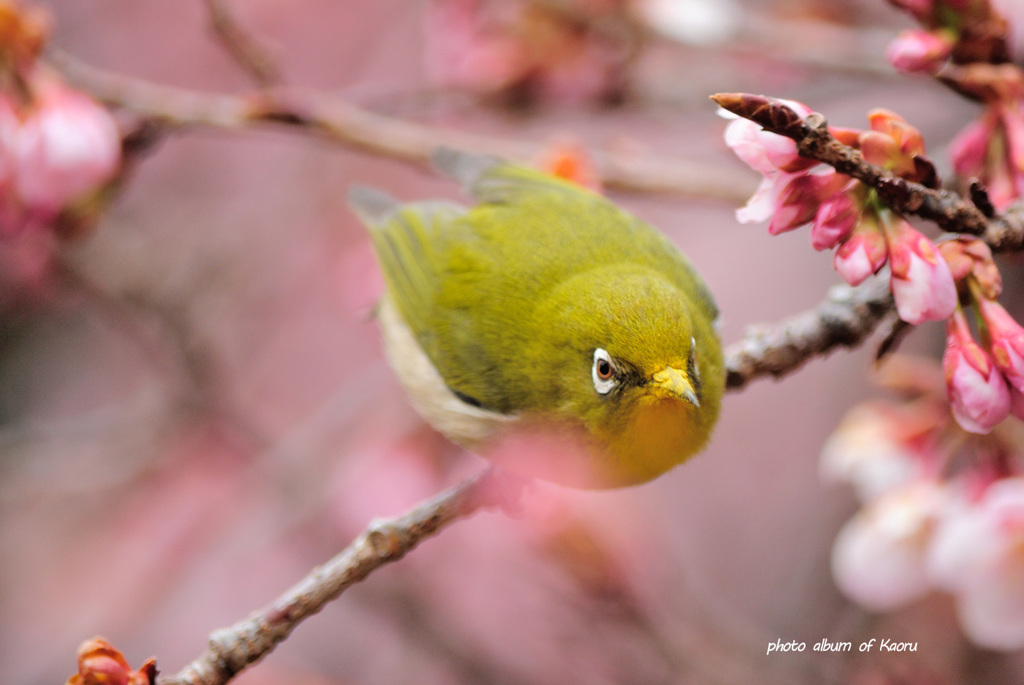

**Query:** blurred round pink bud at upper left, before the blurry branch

left=15, top=86, right=121, bottom=216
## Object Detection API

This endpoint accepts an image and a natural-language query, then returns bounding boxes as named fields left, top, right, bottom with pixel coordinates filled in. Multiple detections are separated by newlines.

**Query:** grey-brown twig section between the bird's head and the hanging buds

left=725, top=279, right=893, bottom=390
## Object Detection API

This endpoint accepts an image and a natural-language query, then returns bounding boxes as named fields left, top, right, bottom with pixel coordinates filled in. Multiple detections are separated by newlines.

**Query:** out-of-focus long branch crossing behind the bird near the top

left=49, top=52, right=753, bottom=203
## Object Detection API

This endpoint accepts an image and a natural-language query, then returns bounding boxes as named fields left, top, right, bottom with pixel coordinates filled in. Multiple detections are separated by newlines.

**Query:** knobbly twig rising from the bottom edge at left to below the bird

left=158, top=469, right=527, bottom=685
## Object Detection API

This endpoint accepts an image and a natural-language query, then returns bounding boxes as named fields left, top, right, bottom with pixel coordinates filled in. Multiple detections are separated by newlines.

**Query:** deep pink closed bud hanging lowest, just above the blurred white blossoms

left=942, top=309, right=1010, bottom=433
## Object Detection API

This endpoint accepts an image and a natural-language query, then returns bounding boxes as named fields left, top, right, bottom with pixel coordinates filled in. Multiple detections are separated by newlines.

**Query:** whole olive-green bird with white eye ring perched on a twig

left=349, top=148, right=725, bottom=487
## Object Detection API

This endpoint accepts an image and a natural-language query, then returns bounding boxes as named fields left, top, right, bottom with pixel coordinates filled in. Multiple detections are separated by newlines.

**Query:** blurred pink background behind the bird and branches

left=0, top=0, right=1024, bottom=685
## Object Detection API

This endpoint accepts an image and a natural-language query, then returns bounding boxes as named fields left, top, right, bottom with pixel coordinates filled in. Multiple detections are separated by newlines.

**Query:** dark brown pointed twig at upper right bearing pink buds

left=712, top=93, right=1024, bottom=252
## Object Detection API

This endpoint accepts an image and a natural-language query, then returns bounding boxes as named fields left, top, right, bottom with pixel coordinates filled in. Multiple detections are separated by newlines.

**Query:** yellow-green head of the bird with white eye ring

left=535, top=266, right=724, bottom=484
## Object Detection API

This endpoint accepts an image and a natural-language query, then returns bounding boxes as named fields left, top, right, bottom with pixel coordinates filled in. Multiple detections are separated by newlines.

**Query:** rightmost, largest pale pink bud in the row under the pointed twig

left=886, top=219, right=956, bottom=325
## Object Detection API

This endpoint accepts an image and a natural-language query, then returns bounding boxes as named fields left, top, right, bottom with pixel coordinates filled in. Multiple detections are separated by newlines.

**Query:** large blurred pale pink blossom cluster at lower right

left=821, top=357, right=1024, bottom=650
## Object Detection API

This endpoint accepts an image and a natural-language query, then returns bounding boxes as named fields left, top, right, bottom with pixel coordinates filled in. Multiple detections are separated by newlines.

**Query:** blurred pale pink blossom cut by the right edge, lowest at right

left=927, top=476, right=1024, bottom=650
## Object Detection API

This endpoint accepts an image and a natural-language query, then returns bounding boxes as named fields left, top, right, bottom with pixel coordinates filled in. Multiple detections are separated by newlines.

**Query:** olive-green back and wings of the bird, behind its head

left=360, top=158, right=717, bottom=413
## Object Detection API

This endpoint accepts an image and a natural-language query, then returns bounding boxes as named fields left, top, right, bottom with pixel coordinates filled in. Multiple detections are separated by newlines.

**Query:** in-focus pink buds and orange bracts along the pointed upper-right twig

left=725, top=105, right=956, bottom=324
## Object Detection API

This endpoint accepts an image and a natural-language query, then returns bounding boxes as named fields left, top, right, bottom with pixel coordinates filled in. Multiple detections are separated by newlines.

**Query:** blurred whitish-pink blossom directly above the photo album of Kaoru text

left=831, top=481, right=948, bottom=611
